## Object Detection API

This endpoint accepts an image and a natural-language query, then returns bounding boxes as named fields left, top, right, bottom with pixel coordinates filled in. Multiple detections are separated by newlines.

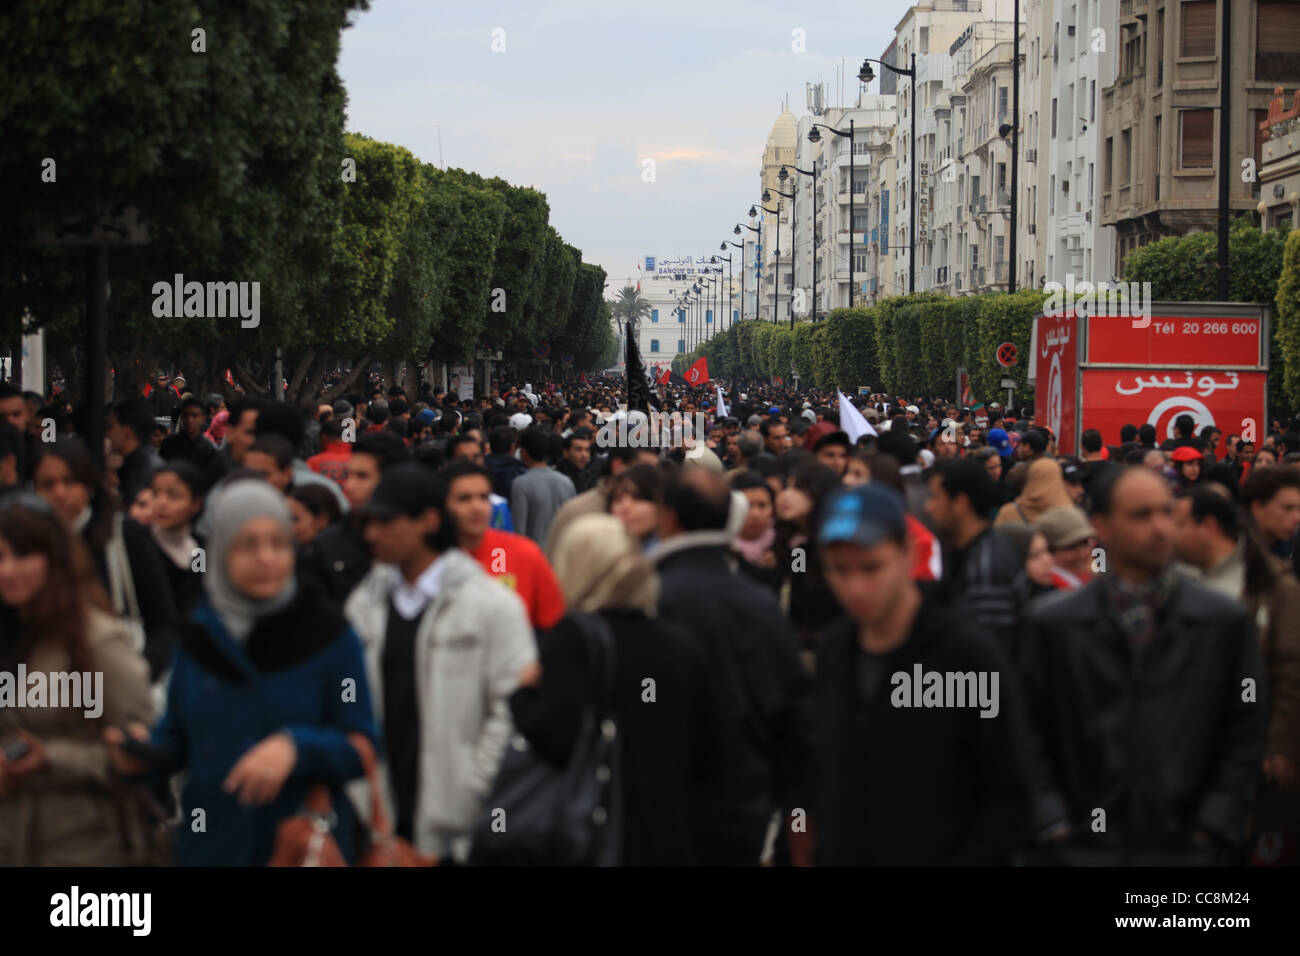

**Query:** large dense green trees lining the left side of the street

left=0, top=0, right=616, bottom=399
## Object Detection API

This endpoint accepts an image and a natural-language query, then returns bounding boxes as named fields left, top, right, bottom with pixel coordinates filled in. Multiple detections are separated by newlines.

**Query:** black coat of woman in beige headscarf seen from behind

left=510, top=611, right=722, bottom=866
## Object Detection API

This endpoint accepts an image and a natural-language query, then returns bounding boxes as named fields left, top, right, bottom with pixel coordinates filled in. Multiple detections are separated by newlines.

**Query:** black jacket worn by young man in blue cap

left=816, top=601, right=1027, bottom=866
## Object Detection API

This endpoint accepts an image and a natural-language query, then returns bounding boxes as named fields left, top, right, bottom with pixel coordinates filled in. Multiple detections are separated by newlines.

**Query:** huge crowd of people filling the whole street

left=0, top=375, right=1300, bottom=866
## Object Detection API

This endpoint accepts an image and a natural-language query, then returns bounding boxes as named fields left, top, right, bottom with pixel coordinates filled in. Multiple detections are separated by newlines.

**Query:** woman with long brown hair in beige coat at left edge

left=0, top=494, right=152, bottom=866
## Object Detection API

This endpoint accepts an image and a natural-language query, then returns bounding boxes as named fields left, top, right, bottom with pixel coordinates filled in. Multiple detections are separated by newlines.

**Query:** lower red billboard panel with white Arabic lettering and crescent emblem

left=1076, top=369, right=1269, bottom=447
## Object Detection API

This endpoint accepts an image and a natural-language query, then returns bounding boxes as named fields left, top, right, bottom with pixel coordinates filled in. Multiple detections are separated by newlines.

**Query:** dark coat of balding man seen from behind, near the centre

left=658, top=535, right=813, bottom=865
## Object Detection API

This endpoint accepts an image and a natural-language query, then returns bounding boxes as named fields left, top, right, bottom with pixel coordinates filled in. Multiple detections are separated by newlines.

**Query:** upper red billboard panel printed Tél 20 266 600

left=1087, top=310, right=1264, bottom=368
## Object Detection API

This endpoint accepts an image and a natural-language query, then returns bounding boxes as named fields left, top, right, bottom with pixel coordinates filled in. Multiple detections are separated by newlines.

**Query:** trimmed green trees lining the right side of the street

left=673, top=217, right=1300, bottom=408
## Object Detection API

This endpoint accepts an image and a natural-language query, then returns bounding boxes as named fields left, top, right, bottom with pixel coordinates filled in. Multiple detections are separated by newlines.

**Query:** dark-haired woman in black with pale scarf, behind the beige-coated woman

left=31, top=438, right=181, bottom=680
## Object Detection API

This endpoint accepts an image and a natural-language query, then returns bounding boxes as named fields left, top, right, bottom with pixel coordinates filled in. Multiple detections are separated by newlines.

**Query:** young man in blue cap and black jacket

left=816, top=483, right=1027, bottom=866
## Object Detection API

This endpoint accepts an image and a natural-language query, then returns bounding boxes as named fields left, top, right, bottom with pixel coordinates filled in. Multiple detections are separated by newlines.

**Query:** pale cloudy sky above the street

left=339, top=0, right=910, bottom=295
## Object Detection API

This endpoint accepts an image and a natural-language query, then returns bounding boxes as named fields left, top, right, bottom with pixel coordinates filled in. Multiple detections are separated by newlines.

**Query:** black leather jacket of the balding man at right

left=1019, top=579, right=1268, bottom=865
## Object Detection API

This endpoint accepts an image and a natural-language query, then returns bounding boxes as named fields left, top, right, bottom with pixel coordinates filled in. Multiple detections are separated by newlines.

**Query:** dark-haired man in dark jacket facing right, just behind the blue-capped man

left=926, top=458, right=1024, bottom=646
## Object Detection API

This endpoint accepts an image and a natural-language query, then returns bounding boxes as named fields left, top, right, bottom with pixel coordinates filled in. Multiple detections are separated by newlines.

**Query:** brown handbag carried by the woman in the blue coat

left=267, top=734, right=438, bottom=866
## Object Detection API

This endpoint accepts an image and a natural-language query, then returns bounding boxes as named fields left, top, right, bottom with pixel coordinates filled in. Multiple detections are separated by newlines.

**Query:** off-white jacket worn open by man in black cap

left=345, top=549, right=537, bottom=862
